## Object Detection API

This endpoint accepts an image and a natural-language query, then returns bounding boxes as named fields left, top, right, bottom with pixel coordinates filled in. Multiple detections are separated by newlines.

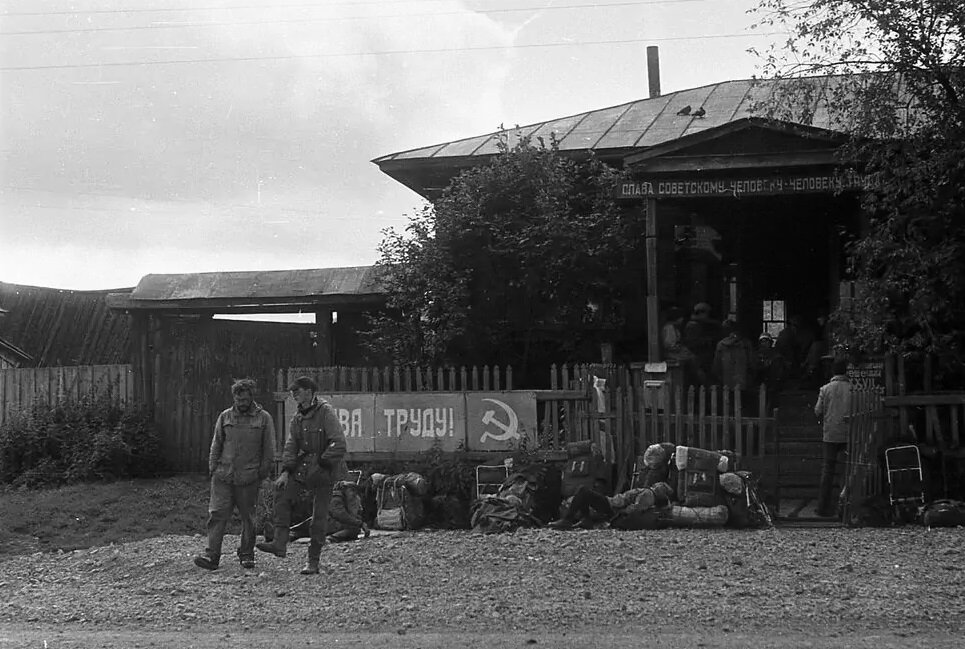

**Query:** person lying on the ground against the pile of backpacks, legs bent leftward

left=547, top=482, right=673, bottom=530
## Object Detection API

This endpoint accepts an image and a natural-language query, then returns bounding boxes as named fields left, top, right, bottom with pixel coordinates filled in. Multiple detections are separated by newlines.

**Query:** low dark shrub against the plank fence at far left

left=0, top=397, right=162, bottom=487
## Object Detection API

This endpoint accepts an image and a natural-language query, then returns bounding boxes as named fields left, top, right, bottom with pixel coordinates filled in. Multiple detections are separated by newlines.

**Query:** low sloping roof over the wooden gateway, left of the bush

left=107, top=266, right=384, bottom=313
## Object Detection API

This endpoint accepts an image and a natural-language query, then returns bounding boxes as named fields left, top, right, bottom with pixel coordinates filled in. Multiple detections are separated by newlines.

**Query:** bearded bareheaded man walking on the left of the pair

left=194, top=379, right=275, bottom=570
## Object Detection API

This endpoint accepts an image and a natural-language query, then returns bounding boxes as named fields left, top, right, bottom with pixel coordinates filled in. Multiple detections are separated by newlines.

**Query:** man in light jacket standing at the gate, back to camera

left=814, top=358, right=851, bottom=517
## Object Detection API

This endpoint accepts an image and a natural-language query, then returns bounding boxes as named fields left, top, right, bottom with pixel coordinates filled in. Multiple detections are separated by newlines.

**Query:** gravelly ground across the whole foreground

left=0, top=527, right=965, bottom=649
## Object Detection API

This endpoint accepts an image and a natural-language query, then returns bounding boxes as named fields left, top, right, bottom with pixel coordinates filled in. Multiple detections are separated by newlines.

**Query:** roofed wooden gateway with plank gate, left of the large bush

left=107, top=266, right=384, bottom=471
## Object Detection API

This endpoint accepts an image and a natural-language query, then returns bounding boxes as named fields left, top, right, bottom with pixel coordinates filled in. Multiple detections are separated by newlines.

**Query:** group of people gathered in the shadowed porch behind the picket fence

left=660, top=302, right=828, bottom=408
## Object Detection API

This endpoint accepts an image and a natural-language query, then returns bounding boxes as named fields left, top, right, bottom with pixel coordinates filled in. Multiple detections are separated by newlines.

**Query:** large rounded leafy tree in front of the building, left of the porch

left=368, top=133, right=643, bottom=376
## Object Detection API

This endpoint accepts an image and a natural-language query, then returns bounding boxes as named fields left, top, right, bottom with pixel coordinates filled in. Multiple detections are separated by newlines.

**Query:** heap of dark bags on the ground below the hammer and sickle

left=470, top=463, right=560, bottom=534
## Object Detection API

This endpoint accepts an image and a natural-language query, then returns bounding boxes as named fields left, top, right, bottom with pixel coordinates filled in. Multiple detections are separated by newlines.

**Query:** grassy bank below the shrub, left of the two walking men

left=0, top=475, right=217, bottom=555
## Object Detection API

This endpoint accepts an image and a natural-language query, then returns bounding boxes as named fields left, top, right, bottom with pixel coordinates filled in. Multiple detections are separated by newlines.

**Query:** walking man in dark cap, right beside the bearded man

left=256, top=376, right=347, bottom=575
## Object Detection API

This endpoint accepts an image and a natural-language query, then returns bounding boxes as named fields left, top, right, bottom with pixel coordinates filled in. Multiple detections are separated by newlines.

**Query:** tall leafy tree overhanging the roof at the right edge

left=757, top=0, right=965, bottom=378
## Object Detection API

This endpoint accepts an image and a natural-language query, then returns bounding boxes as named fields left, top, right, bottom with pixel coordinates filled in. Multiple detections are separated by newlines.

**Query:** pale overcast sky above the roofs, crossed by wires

left=0, top=0, right=774, bottom=289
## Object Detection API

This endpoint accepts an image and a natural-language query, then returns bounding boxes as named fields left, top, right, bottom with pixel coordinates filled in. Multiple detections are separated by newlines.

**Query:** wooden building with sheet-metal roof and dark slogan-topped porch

left=373, top=77, right=862, bottom=361
